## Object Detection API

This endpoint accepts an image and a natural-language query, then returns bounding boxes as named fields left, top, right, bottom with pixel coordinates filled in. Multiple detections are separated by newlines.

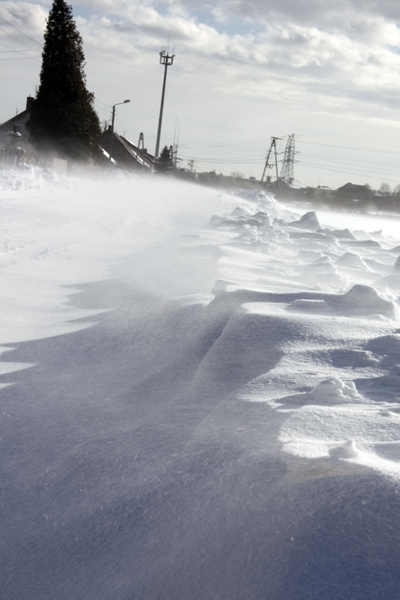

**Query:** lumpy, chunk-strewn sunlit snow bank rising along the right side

left=203, top=190, right=400, bottom=476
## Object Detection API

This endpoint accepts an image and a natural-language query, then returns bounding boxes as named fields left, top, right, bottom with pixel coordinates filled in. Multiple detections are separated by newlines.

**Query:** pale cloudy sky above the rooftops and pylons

left=0, top=0, right=400, bottom=188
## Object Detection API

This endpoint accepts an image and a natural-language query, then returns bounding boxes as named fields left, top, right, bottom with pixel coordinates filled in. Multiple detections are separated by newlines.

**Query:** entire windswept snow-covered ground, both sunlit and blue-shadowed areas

left=0, top=168, right=400, bottom=600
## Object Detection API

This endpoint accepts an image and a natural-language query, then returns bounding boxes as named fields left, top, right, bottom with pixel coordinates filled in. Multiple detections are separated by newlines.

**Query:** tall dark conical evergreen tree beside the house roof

left=27, top=0, right=101, bottom=159
